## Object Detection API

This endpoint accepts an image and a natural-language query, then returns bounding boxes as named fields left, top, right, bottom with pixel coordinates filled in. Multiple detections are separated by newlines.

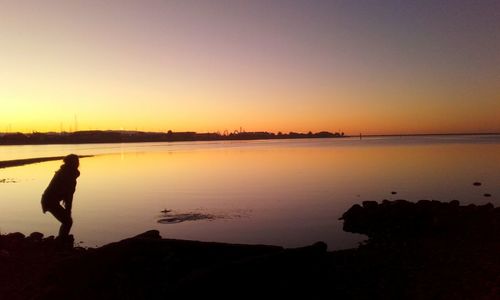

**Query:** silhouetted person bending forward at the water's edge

left=42, top=154, right=80, bottom=240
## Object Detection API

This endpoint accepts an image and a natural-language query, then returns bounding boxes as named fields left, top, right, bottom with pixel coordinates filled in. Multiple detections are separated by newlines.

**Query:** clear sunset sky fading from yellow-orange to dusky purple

left=0, top=0, right=500, bottom=134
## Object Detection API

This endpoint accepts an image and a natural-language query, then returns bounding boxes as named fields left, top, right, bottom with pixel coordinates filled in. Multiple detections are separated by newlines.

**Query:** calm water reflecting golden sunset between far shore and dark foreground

left=0, top=136, right=500, bottom=249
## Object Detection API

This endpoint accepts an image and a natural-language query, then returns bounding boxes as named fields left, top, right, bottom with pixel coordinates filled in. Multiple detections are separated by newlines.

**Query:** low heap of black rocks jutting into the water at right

left=341, top=200, right=500, bottom=239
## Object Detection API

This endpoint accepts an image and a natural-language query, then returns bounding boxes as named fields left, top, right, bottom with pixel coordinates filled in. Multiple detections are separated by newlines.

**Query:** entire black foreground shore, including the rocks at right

left=0, top=200, right=500, bottom=299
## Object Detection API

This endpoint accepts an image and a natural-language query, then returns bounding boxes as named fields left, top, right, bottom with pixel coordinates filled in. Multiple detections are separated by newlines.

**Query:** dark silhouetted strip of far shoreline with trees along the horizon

left=0, top=130, right=344, bottom=145
